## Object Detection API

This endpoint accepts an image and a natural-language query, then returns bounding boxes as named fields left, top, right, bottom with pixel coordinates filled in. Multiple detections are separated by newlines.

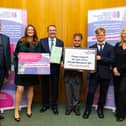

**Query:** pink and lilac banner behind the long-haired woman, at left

left=0, top=8, right=27, bottom=111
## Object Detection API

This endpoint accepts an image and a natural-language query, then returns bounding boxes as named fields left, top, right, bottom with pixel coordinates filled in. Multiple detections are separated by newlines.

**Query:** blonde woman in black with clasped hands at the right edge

left=113, top=28, right=126, bottom=121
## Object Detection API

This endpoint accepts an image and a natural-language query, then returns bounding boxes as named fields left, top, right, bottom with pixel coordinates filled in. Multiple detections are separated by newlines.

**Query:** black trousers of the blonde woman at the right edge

left=114, top=76, right=126, bottom=117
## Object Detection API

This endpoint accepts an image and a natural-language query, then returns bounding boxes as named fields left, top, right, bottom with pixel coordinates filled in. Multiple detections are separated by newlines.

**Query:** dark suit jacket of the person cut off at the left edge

left=0, top=34, right=11, bottom=73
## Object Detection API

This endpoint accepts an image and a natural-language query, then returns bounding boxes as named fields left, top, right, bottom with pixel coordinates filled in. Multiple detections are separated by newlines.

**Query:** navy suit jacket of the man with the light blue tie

left=40, top=38, right=64, bottom=73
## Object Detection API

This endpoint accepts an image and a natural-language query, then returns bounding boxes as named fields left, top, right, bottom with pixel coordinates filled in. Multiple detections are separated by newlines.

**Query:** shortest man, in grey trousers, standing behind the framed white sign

left=64, top=33, right=82, bottom=116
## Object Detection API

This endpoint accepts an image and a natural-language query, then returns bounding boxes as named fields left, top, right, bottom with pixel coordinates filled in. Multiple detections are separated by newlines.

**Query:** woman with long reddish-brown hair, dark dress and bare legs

left=14, top=25, right=40, bottom=121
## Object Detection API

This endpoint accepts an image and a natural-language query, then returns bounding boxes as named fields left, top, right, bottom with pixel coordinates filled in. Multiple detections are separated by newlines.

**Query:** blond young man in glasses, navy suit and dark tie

left=83, top=28, right=114, bottom=119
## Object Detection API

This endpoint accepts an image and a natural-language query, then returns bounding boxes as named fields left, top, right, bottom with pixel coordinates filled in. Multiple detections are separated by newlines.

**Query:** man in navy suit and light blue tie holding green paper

left=40, top=25, right=64, bottom=114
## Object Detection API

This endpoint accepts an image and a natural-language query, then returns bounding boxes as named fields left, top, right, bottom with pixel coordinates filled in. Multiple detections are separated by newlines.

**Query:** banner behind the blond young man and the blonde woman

left=88, top=7, right=126, bottom=110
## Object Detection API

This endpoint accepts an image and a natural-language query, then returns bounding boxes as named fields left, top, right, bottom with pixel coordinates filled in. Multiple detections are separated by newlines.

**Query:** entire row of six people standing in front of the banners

left=0, top=19, right=126, bottom=121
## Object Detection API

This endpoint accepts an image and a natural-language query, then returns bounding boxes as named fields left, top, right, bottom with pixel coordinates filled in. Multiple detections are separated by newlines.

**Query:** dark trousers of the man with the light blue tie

left=42, top=73, right=59, bottom=108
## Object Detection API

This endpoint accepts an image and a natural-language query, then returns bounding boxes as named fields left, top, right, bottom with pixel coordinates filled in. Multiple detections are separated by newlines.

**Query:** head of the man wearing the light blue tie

left=47, top=25, right=56, bottom=38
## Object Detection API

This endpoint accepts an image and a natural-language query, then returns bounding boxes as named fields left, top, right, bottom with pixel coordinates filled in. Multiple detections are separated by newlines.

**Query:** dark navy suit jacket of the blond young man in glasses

left=90, top=42, right=114, bottom=79
